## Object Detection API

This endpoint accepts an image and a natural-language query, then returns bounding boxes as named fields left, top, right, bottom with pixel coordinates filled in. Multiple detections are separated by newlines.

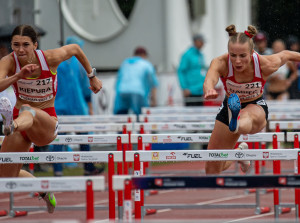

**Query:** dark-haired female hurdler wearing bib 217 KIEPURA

left=0, top=25, right=102, bottom=213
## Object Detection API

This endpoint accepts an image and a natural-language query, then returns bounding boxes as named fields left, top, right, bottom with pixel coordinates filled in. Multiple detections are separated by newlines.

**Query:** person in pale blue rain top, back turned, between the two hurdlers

left=114, top=47, right=158, bottom=119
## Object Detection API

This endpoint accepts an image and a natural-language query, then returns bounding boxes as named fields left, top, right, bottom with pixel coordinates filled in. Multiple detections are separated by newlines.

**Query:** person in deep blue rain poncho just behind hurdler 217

left=53, top=36, right=104, bottom=176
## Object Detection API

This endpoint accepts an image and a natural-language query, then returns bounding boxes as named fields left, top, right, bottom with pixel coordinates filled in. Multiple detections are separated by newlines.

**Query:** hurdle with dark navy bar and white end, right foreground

left=113, top=173, right=300, bottom=222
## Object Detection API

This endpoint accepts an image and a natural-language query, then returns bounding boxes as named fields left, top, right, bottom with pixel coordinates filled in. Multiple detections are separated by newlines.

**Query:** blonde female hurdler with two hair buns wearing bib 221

left=203, top=25, right=300, bottom=174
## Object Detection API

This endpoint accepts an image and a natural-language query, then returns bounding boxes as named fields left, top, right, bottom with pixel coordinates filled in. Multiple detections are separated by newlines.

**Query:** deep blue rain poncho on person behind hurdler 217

left=55, top=56, right=91, bottom=115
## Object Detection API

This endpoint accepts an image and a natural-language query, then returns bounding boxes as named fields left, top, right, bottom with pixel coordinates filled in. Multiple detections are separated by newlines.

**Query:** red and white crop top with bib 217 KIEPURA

left=13, top=50, right=57, bottom=102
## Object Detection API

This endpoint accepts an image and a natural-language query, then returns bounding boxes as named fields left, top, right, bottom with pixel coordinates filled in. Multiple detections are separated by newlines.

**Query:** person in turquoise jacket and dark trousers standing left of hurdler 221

left=177, top=34, right=206, bottom=106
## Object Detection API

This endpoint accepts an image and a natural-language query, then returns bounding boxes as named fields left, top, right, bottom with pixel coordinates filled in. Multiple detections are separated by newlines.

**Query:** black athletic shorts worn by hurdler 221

left=216, top=96, right=269, bottom=126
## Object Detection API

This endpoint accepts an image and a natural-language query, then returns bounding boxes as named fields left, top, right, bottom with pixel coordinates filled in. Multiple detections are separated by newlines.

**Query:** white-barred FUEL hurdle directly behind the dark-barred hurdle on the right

left=123, top=149, right=300, bottom=220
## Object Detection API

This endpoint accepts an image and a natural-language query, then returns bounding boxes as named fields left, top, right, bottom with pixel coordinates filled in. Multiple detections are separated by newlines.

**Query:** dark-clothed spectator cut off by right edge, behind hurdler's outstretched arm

left=287, top=35, right=300, bottom=99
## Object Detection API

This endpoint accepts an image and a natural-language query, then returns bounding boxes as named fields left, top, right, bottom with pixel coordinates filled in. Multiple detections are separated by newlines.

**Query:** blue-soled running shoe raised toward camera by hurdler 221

left=228, top=93, right=241, bottom=133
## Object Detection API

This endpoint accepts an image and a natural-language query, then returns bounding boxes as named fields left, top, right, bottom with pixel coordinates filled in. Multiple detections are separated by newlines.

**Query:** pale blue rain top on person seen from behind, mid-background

left=116, top=56, right=158, bottom=105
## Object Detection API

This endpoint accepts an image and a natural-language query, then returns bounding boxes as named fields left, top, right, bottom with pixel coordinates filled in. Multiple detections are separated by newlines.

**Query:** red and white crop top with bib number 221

left=221, top=52, right=266, bottom=101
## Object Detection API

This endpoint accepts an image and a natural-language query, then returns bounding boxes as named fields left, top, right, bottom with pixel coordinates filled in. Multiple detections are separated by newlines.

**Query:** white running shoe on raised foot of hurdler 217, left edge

left=0, top=97, right=14, bottom=136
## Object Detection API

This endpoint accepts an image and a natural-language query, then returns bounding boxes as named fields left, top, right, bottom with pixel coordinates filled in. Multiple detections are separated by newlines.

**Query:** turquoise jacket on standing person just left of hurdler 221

left=177, top=46, right=206, bottom=95
